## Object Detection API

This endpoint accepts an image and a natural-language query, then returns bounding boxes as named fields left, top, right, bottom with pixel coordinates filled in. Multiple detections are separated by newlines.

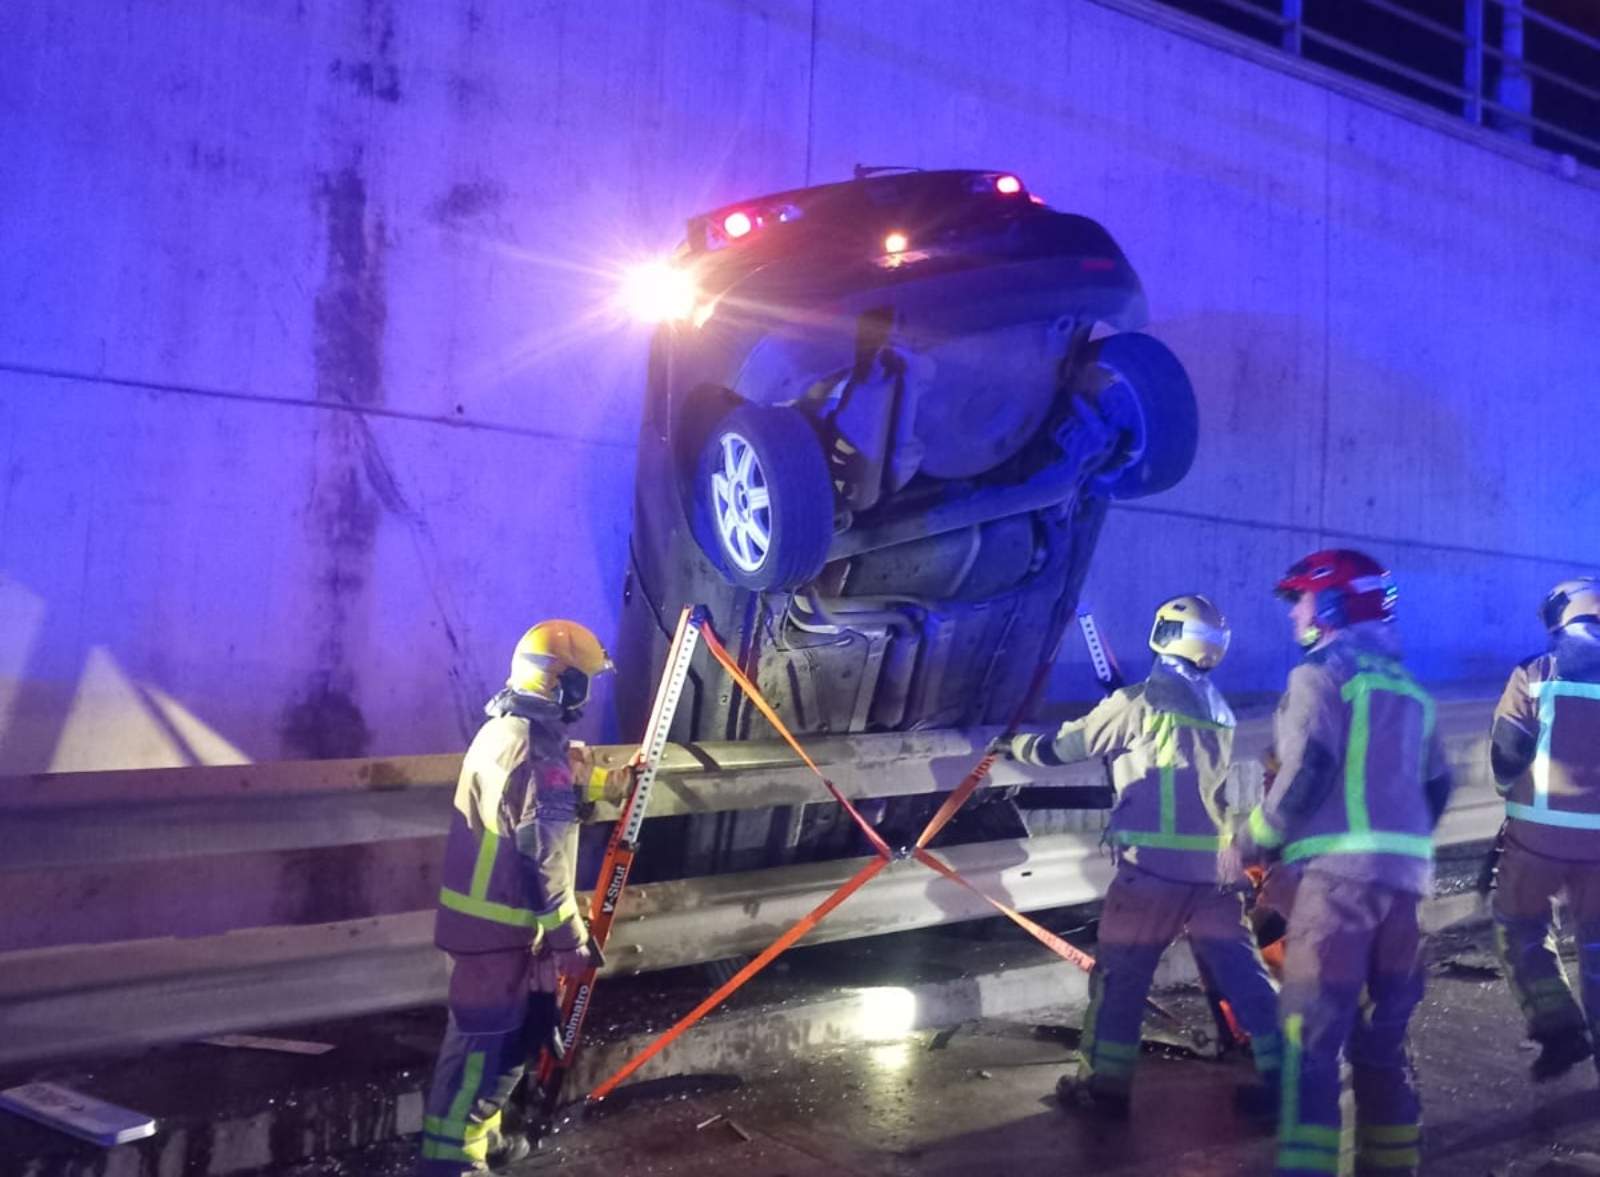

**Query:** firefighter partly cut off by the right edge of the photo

left=1490, top=577, right=1600, bottom=1081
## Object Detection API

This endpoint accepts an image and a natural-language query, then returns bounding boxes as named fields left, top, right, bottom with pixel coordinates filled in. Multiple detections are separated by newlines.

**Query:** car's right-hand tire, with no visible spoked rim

left=1080, top=331, right=1200, bottom=499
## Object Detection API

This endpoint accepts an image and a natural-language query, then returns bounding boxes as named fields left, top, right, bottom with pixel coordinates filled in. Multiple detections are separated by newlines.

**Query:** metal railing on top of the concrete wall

left=1165, top=0, right=1600, bottom=166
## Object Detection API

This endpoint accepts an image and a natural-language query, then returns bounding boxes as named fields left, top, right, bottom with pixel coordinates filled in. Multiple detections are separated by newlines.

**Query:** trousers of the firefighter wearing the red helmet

left=1277, top=867, right=1422, bottom=1177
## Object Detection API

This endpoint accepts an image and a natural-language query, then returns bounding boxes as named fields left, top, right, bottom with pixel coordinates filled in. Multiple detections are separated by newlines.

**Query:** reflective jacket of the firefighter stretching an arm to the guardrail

left=1018, top=659, right=1234, bottom=883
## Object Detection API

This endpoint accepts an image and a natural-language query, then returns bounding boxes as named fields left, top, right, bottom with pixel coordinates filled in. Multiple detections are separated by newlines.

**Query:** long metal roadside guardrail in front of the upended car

left=0, top=700, right=1502, bottom=1063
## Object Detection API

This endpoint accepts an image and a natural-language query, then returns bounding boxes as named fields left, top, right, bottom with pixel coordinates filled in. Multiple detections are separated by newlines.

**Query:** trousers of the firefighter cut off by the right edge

left=1493, top=841, right=1600, bottom=1041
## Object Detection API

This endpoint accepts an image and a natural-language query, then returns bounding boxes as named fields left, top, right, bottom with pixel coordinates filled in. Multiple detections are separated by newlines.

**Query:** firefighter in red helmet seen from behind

left=1237, top=549, right=1451, bottom=1177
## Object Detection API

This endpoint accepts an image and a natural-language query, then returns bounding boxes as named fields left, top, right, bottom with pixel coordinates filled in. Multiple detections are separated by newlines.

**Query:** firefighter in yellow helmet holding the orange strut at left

left=419, top=620, right=632, bottom=1177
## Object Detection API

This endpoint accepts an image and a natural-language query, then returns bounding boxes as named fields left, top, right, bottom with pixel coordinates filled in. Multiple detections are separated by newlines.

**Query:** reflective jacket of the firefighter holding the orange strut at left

left=434, top=691, right=589, bottom=953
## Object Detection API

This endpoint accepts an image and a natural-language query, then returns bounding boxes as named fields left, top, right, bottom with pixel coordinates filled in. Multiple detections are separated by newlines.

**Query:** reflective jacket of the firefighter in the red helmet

left=1250, top=622, right=1450, bottom=894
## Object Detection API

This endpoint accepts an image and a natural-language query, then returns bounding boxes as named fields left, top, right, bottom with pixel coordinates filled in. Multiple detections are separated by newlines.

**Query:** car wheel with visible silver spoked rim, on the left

left=694, top=405, right=834, bottom=590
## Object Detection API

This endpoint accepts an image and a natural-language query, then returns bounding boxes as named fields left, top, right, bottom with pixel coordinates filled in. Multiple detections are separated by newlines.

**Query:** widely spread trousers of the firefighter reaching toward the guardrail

left=1078, top=862, right=1278, bottom=1097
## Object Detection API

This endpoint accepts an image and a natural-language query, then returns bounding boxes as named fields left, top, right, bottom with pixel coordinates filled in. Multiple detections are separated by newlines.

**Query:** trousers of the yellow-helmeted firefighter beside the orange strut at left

left=418, top=948, right=533, bottom=1177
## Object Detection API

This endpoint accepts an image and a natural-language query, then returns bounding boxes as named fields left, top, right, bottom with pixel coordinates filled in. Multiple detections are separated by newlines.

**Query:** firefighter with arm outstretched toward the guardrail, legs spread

left=1010, top=595, right=1278, bottom=1119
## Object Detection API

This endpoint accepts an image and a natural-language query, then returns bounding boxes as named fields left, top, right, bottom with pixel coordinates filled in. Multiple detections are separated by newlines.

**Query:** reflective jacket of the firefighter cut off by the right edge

left=1490, top=633, right=1600, bottom=862
